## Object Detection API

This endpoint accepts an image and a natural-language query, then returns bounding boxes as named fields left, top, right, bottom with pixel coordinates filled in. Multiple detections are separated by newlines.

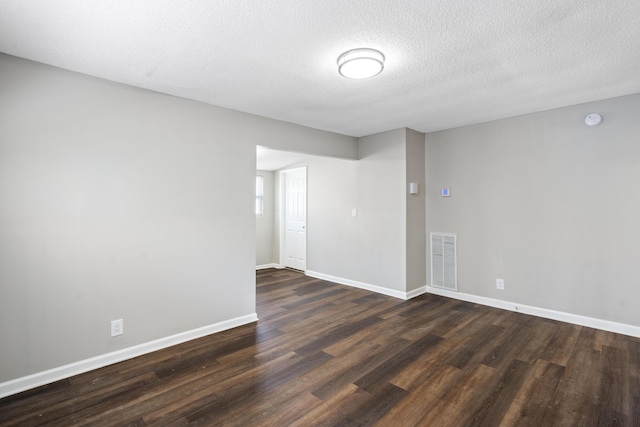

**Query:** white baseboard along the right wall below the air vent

left=427, top=286, right=640, bottom=338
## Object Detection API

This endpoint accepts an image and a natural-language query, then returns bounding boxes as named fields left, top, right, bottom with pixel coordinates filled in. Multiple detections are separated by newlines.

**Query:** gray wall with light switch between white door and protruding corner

left=296, top=129, right=408, bottom=292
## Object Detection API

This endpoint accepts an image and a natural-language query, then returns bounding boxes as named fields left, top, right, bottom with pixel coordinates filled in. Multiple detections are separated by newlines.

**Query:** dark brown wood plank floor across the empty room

left=0, top=270, right=640, bottom=427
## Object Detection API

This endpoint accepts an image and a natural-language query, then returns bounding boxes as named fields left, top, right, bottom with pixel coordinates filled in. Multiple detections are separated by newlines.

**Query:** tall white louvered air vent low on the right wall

left=431, top=233, right=458, bottom=291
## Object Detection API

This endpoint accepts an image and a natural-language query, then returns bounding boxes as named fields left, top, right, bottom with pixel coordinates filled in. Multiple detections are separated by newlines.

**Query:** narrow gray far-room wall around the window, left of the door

left=256, top=170, right=278, bottom=265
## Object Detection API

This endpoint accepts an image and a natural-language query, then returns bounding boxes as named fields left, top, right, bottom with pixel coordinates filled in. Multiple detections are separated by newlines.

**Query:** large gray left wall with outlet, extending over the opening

left=0, top=55, right=357, bottom=381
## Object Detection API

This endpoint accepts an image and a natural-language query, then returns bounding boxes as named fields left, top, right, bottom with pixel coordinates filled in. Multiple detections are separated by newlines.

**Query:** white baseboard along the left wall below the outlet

left=0, top=313, right=258, bottom=398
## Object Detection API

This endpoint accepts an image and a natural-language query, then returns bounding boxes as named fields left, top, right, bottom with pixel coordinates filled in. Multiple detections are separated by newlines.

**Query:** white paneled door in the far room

left=283, top=168, right=307, bottom=271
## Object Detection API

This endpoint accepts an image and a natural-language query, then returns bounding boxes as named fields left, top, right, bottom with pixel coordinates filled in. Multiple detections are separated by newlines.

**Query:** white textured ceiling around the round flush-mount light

left=0, top=0, right=640, bottom=136
